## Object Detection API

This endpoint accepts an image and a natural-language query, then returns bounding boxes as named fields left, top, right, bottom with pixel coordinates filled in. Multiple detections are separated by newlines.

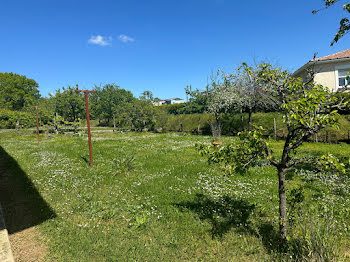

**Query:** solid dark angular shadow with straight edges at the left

left=0, top=146, right=56, bottom=234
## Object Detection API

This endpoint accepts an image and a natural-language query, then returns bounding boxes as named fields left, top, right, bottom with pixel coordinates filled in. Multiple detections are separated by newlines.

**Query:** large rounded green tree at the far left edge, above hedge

left=0, top=73, right=40, bottom=110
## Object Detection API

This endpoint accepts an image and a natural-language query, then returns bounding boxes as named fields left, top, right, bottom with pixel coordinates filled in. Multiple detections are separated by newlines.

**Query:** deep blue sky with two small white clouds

left=0, top=0, right=350, bottom=98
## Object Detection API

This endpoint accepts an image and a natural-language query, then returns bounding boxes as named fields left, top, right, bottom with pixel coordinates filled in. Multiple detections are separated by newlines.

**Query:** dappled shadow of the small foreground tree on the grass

left=175, top=194, right=283, bottom=253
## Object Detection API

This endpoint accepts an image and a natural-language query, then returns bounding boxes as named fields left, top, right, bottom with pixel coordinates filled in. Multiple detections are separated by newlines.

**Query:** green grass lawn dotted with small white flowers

left=0, top=131, right=350, bottom=261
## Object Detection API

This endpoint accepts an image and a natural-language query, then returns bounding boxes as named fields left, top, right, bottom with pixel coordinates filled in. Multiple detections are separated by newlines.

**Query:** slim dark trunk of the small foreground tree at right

left=278, top=168, right=287, bottom=245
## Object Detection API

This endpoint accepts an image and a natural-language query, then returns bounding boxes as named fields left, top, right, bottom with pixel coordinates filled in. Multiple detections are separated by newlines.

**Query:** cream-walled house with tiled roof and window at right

left=293, top=49, right=350, bottom=91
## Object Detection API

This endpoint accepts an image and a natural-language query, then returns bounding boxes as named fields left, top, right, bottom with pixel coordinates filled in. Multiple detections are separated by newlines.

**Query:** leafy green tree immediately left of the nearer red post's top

left=54, top=85, right=85, bottom=121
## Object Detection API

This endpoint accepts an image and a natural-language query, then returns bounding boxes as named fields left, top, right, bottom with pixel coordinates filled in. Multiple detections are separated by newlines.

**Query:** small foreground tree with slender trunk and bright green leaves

left=199, top=64, right=343, bottom=243
